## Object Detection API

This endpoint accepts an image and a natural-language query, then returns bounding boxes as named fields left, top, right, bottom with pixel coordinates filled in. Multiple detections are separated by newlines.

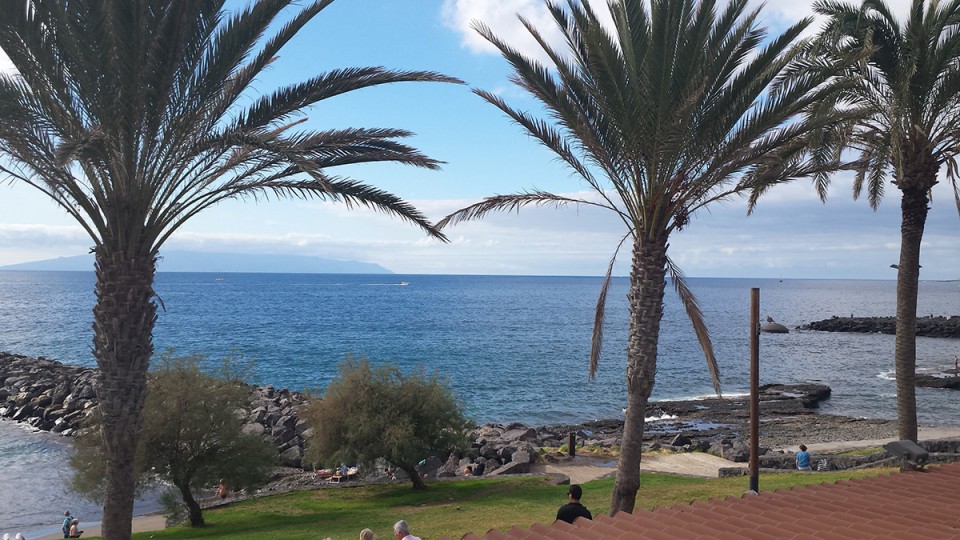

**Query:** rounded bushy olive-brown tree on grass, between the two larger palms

left=303, top=357, right=471, bottom=489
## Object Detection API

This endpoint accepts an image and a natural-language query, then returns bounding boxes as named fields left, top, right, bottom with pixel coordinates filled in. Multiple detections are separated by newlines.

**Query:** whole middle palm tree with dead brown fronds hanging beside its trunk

left=438, top=0, right=839, bottom=512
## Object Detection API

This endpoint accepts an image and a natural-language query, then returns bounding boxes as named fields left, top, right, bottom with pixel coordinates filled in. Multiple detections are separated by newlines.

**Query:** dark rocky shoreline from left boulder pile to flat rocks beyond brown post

left=0, top=353, right=956, bottom=476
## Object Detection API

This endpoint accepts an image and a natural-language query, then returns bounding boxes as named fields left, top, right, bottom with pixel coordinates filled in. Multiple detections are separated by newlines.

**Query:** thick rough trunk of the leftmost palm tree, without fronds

left=93, top=246, right=157, bottom=540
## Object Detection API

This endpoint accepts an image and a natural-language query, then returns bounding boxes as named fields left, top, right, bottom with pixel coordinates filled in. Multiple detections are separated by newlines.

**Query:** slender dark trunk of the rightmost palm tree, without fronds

left=894, top=189, right=928, bottom=442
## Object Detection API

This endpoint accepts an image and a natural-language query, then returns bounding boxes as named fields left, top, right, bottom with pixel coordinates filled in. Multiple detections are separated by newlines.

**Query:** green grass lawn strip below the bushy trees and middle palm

left=118, top=469, right=894, bottom=540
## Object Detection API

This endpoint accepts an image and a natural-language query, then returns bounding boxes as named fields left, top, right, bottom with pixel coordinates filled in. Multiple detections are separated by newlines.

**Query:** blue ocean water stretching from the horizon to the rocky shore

left=0, top=271, right=960, bottom=538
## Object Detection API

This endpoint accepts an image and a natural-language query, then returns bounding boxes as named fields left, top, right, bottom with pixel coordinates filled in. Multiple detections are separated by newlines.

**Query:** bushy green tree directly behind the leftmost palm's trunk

left=70, top=356, right=277, bottom=527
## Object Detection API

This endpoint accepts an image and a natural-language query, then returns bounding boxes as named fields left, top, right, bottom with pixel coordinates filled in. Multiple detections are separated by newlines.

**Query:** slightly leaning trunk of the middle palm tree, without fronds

left=610, top=241, right=667, bottom=515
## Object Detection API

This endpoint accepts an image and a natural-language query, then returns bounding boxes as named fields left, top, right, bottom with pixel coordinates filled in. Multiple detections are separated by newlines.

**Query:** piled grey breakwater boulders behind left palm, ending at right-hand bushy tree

left=0, top=352, right=308, bottom=467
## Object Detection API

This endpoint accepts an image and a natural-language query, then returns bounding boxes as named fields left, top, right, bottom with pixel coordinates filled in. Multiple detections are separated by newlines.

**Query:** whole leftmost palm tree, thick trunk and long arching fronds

left=0, top=0, right=458, bottom=539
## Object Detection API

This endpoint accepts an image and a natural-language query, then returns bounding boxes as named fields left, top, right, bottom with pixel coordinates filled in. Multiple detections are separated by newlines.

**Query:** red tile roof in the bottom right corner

left=454, top=463, right=960, bottom=540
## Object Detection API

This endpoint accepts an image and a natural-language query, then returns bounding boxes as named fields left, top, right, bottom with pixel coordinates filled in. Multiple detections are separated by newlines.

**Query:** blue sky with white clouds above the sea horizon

left=0, top=0, right=960, bottom=279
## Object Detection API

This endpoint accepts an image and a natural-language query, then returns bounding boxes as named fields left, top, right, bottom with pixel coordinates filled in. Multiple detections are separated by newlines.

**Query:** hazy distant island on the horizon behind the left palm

left=0, top=251, right=393, bottom=274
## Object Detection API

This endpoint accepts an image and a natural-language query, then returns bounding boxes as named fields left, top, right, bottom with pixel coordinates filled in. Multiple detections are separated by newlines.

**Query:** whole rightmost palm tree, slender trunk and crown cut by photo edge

left=814, top=0, right=960, bottom=441
